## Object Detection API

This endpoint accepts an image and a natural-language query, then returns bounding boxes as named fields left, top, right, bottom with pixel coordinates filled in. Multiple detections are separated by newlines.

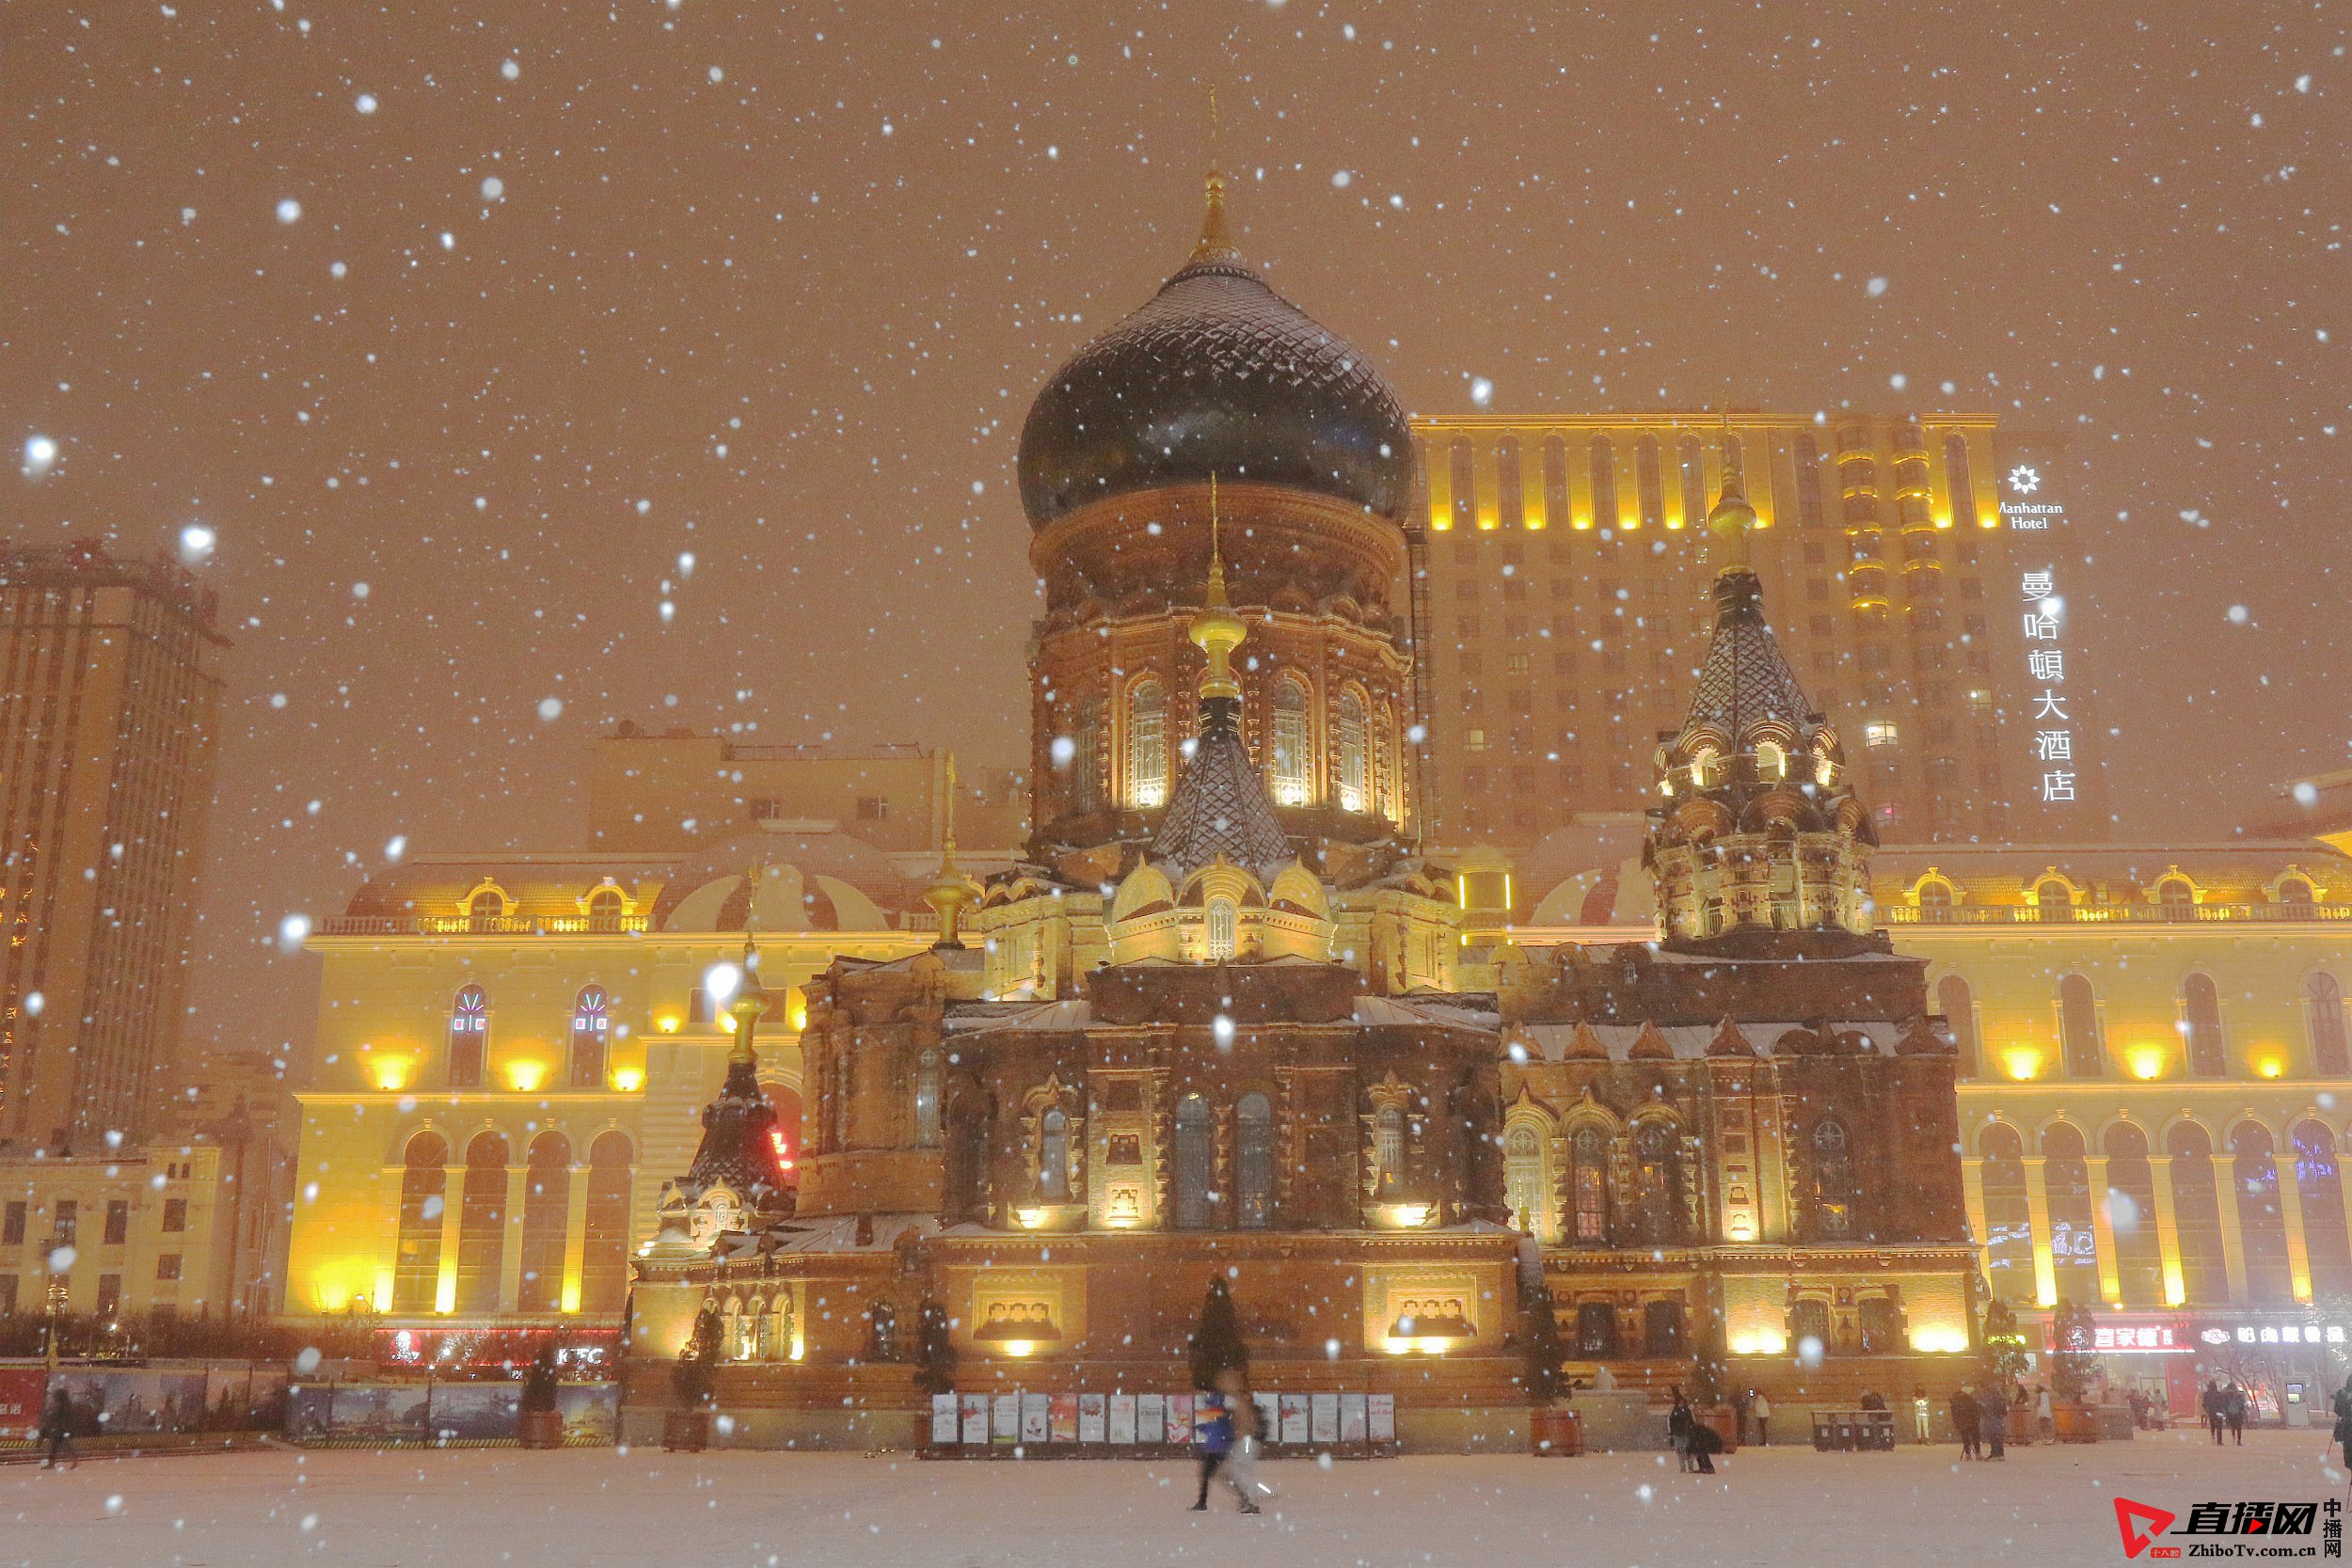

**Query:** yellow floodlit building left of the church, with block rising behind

left=285, top=734, right=1011, bottom=1356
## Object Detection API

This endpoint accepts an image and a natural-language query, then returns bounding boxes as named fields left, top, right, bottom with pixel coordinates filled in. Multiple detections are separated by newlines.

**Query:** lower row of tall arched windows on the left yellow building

left=393, top=1131, right=633, bottom=1317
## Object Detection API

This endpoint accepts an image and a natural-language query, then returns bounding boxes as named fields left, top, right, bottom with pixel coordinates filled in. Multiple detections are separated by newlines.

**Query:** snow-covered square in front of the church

left=0, top=1432, right=2345, bottom=1568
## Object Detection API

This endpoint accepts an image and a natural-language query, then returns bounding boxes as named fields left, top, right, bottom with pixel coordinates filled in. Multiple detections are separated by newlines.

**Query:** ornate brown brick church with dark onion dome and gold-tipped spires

left=626, top=179, right=1974, bottom=1449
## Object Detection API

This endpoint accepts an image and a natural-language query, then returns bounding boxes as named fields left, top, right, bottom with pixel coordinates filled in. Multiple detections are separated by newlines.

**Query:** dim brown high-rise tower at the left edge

left=0, top=543, right=224, bottom=1149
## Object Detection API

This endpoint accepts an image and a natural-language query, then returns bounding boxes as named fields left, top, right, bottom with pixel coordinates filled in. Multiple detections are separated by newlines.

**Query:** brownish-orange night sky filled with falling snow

left=0, top=0, right=2352, bottom=1071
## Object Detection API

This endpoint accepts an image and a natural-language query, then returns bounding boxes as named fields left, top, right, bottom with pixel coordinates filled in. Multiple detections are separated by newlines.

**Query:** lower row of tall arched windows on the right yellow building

left=1979, top=1121, right=2352, bottom=1307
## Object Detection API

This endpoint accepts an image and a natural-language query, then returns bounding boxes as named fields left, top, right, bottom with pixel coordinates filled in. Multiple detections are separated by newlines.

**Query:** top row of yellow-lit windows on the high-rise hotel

left=1439, top=428, right=1983, bottom=529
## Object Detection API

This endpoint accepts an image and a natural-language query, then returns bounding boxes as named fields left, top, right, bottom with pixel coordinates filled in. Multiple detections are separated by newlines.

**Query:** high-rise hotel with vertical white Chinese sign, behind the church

left=1414, top=411, right=2106, bottom=853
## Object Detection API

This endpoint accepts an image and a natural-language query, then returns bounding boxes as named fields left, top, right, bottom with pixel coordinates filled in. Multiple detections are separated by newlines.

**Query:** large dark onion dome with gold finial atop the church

left=1021, top=171, right=1414, bottom=529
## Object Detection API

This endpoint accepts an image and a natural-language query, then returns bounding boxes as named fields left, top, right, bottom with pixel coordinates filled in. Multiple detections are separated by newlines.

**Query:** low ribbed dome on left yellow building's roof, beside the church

left=654, top=818, right=913, bottom=933
